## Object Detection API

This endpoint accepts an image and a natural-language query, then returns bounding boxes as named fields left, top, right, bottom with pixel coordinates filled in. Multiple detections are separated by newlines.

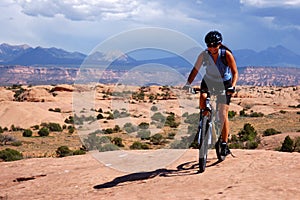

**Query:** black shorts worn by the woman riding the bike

left=201, top=78, right=232, bottom=105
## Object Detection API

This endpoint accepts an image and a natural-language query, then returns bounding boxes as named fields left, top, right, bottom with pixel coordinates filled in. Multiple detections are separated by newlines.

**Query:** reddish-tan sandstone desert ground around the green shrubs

left=0, top=85, right=300, bottom=199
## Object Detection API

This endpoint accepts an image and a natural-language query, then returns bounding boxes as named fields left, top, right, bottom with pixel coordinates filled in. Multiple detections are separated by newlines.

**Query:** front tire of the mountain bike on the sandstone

left=199, top=116, right=209, bottom=173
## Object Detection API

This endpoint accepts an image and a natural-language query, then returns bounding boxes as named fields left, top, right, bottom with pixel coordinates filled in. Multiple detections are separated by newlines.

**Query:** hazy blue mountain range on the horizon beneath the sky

left=0, top=43, right=300, bottom=69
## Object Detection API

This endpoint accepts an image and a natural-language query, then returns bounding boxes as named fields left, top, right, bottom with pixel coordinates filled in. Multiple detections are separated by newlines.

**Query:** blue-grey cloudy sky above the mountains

left=0, top=0, right=300, bottom=54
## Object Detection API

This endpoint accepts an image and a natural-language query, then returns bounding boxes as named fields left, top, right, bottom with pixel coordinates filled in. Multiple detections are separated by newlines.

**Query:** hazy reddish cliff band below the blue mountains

left=0, top=66, right=300, bottom=86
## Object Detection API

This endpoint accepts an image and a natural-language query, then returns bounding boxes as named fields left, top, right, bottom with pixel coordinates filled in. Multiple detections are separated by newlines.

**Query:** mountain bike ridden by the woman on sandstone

left=193, top=88, right=232, bottom=173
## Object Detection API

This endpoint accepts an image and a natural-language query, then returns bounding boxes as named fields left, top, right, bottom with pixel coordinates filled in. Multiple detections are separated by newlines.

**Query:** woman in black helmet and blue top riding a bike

left=184, top=31, right=238, bottom=156
